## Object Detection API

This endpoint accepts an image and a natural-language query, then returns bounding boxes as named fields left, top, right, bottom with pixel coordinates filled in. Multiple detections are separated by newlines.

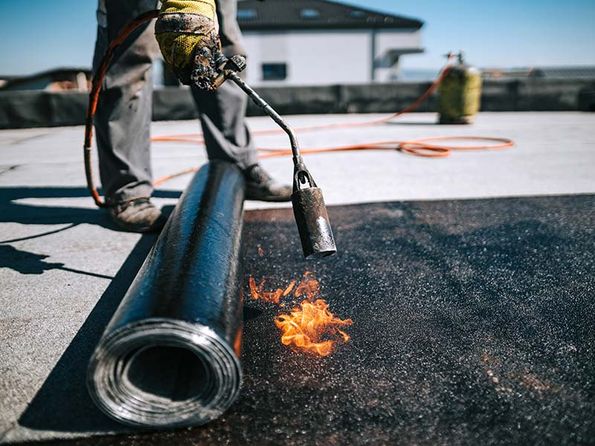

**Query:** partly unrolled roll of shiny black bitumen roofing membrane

left=87, top=161, right=245, bottom=428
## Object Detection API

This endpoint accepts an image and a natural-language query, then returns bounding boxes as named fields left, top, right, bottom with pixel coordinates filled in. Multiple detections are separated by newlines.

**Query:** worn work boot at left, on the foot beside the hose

left=109, top=197, right=167, bottom=232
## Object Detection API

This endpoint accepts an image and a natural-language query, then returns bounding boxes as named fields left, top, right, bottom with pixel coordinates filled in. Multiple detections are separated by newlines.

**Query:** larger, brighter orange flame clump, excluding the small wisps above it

left=275, top=299, right=353, bottom=356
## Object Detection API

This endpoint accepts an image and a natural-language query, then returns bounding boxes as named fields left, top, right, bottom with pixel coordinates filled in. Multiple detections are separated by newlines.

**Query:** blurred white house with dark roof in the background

left=237, top=0, right=423, bottom=85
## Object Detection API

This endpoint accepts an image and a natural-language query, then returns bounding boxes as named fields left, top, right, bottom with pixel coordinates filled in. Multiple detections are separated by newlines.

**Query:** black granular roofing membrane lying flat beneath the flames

left=16, top=195, right=595, bottom=445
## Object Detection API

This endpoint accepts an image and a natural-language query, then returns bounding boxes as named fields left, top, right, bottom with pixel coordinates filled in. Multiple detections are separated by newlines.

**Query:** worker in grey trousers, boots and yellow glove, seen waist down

left=93, top=0, right=292, bottom=232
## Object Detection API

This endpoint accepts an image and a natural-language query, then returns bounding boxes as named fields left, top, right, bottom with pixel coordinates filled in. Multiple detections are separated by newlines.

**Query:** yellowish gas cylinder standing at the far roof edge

left=438, top=52, right=481, bottom=124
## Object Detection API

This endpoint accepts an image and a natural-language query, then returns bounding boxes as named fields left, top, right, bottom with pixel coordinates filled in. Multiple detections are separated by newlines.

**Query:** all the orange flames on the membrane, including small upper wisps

left=248, top=271, right=353, bottom=356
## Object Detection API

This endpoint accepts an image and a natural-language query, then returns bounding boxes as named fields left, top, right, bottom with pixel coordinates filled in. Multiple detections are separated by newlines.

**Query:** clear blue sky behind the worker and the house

left=0, top=0, right=595, bottom=75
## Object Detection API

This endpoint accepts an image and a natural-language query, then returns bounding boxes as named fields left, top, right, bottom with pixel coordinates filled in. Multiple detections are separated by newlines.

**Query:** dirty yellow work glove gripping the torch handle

left=155, top=0, right=222, bottom=90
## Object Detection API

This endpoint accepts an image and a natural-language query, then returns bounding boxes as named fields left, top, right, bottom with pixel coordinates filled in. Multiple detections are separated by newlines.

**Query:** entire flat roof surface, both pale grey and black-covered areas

left=0, top=112, right=595, bottom=446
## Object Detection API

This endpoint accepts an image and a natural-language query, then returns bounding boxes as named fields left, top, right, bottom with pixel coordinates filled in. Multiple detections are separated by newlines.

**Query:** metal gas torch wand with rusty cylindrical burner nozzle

left=213, top=55, right=337, bottom=258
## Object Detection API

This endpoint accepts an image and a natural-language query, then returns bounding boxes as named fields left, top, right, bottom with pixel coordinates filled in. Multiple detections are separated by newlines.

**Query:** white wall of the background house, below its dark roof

left=244, top=30, right=420, bottom=86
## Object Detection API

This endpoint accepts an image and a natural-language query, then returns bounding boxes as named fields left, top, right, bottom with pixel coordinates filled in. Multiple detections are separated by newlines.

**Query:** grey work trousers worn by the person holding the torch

left=93, top=0, right=257, bottom=203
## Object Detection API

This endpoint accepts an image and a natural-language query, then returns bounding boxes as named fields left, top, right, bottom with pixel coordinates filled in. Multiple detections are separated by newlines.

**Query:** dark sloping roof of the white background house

left=238, top=0, right=423, bottom=31
